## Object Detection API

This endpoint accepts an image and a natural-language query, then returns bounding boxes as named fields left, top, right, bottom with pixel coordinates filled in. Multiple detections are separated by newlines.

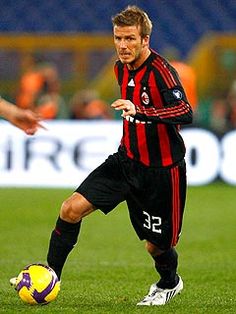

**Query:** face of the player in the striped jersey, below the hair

left=113, top=25, right=149, bottom=69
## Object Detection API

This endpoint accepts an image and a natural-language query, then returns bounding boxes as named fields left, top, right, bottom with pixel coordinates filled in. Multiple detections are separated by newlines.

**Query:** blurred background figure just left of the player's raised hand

left=70, top=89, right=113, bottom=120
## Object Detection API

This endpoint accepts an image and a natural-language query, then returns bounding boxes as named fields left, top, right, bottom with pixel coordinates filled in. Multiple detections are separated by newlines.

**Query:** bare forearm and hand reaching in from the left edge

left=0, top=97, right=42, bottom=135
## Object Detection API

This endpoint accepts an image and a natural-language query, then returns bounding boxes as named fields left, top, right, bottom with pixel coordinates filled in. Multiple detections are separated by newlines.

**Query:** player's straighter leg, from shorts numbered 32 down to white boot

left=128, top=162, right=186, bottom=305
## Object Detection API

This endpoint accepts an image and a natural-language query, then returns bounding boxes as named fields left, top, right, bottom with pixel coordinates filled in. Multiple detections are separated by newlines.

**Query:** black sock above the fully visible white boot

left=153, top=248, right=179, bottom=289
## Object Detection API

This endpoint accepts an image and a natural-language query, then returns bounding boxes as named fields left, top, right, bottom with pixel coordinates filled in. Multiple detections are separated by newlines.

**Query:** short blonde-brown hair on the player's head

left=112, top=5, right=152, bottom=37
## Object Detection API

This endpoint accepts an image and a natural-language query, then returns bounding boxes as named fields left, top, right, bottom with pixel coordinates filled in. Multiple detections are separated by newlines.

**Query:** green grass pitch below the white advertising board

left=0, top=184, right=236, bottom=314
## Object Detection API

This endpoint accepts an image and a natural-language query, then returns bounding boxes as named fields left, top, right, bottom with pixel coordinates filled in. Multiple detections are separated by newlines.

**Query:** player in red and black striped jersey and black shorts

left=47, top=6, right=192, bottom=305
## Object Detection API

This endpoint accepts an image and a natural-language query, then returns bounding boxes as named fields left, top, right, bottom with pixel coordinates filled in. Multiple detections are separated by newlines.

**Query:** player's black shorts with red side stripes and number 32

left=76, top=153, right=186, bottom=250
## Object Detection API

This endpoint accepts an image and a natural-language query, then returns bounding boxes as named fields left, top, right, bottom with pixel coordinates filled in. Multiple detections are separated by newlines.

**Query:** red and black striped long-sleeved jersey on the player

left=114, top=50, right=192, bottom=167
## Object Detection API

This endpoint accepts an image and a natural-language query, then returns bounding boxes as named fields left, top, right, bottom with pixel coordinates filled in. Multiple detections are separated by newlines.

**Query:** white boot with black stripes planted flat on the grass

left=137, top=276, right=184, bottom=306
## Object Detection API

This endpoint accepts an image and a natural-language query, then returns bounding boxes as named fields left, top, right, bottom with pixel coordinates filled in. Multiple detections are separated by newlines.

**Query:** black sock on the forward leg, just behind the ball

left=47, top=217, right=81, bottom=279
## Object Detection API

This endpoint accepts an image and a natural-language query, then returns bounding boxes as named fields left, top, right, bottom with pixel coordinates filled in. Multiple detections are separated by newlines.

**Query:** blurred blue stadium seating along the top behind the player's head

left=0, top=0, right=236, bottom=57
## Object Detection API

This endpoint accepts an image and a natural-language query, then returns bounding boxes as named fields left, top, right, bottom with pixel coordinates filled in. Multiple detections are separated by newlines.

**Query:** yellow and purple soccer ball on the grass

left=16, top=264, right=60, bottom=305
